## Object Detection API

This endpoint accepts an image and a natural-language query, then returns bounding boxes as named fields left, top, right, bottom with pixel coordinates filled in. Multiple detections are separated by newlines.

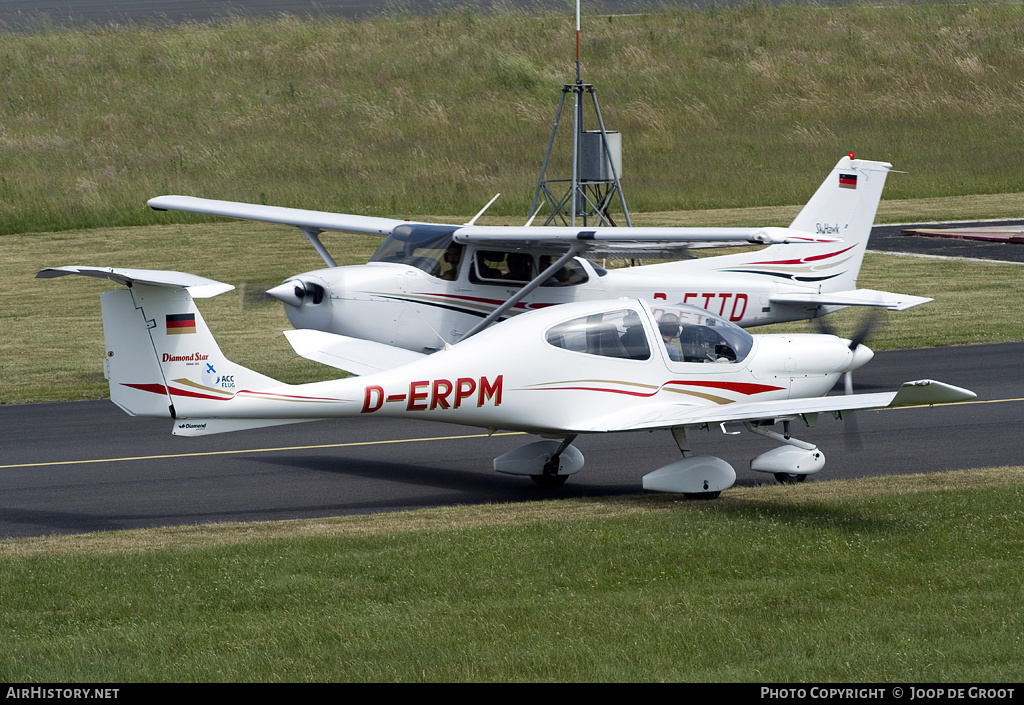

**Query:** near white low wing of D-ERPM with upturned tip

left=572, top=379, right=977, bottom=433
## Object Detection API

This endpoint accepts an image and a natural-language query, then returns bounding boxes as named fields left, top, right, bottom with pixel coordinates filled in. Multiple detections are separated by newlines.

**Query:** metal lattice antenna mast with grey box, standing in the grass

left=529, top=0, right=633, bottom=226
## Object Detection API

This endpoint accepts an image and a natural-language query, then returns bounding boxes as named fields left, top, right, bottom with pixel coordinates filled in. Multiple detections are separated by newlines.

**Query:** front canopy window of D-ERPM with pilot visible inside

left=653, top=303, right=754, bottom=363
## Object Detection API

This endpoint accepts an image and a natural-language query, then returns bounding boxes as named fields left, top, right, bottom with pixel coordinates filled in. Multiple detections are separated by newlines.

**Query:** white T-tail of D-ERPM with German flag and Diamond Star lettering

left=37, top=266, right=356, bottom=436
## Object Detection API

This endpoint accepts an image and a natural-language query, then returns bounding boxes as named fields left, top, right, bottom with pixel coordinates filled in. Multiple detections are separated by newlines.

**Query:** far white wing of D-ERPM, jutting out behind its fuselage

left=285, top=329, right=426, bottom=375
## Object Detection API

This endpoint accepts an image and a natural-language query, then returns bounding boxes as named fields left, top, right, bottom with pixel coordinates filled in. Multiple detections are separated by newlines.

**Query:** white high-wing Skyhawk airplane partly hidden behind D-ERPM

left=148, top=156, right=931, bottom=353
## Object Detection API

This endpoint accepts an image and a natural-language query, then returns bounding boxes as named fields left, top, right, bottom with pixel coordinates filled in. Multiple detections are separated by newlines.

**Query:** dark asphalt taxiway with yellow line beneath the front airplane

left=0, top=343, right=1024, bottom=537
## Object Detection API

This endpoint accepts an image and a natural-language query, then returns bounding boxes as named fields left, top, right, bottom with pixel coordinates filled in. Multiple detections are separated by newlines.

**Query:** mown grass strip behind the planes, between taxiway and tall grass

left=8, top=213, right=1024, bottom=404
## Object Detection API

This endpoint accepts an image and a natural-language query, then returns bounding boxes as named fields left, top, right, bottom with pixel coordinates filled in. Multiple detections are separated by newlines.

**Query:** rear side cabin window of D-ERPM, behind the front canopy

left=546, top=308, right=650, bottom=360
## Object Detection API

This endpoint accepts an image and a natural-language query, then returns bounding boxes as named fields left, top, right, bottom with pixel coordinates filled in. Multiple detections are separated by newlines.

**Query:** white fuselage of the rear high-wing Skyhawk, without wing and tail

left=276, top=240, right=843, bottom=351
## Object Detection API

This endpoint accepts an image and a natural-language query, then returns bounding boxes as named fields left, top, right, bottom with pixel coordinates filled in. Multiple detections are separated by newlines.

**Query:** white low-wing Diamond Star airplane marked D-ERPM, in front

left=37, top=266, right=974, bottom=496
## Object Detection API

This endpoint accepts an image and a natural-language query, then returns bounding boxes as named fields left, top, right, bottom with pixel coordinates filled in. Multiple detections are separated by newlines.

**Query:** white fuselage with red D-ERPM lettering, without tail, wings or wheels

left=178, top=300, right=870, bottom=434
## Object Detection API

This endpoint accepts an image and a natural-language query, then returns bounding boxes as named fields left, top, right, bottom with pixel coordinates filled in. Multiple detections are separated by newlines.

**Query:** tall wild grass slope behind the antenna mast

left=0, top=3, right=1024, bottom=233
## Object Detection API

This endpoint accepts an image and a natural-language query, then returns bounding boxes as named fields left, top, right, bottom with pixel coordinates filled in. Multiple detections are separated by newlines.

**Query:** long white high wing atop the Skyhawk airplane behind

left=147, top=196, right=840, bottom=256
